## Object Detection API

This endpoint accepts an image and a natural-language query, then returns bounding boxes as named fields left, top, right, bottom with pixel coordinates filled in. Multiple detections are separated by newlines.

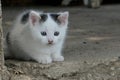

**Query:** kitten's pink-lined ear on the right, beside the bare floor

left=58, top=11, right=69, bottom=25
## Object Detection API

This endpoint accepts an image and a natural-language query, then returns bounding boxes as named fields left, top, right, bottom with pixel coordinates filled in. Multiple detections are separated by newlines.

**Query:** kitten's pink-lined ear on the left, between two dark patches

left=29, top=11, right=41, bottom=26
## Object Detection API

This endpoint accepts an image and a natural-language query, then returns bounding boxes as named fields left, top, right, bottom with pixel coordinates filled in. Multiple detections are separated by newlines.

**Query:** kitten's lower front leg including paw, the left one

left=34, top=54, right=52, bottom=64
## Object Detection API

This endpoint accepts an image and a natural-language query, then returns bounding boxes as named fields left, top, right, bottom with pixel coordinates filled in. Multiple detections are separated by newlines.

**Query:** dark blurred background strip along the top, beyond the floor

left=2, top=0, right=120, bottom=7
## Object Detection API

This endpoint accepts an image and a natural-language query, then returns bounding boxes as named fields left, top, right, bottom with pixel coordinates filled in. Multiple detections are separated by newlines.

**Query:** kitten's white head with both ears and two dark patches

left=21, top=11, right=69, bottom=44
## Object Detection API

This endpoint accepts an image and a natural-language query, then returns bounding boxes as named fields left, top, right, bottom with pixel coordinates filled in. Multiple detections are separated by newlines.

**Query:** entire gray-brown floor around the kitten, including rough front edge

left=3, top=5, right=120, bottom=80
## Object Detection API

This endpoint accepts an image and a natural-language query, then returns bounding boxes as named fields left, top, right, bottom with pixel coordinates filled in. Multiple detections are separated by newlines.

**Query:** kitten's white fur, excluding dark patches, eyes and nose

left=6, top=11, right=69, bottom=64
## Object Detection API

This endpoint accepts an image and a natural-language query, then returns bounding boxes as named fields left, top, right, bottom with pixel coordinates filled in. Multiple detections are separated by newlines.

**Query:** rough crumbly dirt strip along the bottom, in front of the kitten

left=4, top=60, right=120, bottom=80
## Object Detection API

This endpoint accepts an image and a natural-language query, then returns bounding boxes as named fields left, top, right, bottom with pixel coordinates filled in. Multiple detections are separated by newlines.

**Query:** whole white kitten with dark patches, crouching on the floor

left=5, top=10, right=69, bottom=64
